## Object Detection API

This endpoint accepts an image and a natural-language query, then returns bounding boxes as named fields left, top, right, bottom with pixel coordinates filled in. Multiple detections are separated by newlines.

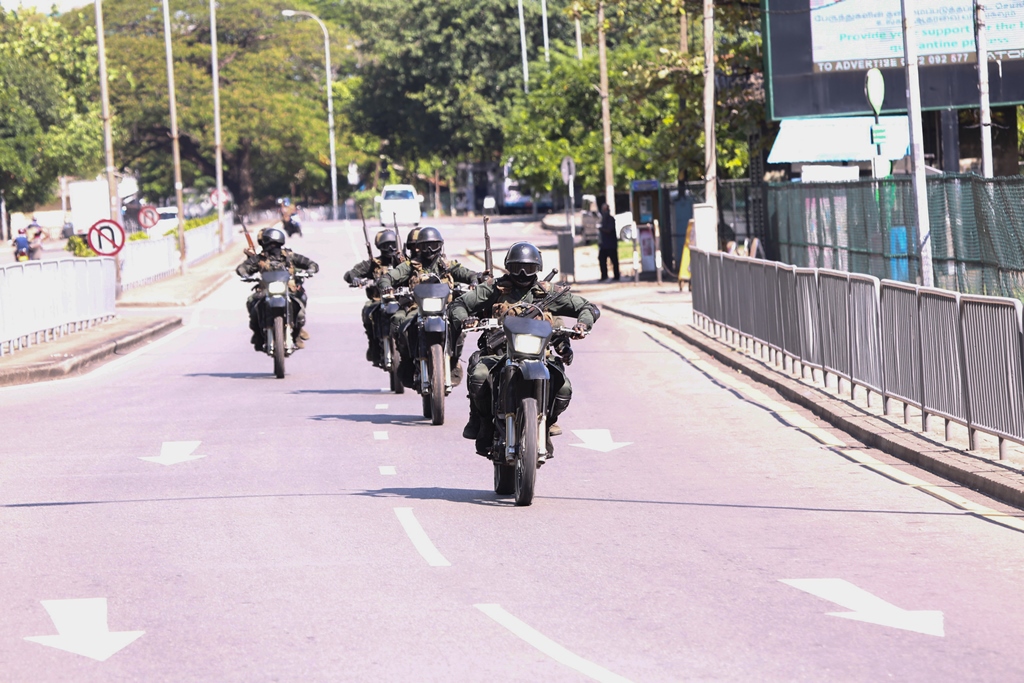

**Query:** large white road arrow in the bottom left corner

left=26, top=598, right=145, bottom=661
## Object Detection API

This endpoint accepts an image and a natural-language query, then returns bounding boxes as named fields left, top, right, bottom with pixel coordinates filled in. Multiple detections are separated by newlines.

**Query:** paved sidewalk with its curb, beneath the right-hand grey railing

left=591, top=284, right=1024, bottom=511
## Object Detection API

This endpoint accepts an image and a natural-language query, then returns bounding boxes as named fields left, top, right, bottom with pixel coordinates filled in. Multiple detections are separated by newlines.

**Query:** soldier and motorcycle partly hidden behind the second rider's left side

left=344, top=229, right=404, bottom=393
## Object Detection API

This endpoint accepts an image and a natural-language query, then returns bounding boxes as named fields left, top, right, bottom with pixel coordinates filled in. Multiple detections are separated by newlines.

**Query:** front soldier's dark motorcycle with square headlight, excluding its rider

left=466, top=315, right=588, bottom=506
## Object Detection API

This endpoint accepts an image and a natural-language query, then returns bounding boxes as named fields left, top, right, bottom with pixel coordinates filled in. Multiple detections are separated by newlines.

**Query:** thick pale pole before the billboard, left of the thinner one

left=900, top=0, right=935, bottom=287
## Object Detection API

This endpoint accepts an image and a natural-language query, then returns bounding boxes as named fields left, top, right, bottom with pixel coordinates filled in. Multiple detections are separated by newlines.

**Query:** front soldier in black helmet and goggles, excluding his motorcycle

left=451, top=242, right=601, bottom=456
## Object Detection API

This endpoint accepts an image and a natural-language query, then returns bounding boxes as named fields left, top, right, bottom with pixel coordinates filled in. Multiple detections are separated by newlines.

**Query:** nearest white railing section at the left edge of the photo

left=0, top=258, right=117, bottom=355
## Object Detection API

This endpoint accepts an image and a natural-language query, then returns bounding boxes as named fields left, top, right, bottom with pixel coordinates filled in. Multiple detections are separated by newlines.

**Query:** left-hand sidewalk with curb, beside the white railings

left=0, top=241, right=251, bottom=386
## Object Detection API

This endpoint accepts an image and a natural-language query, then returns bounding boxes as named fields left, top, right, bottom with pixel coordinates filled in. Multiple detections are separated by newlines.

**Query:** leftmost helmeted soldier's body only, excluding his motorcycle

left=234, top=226, right=319, bottom=351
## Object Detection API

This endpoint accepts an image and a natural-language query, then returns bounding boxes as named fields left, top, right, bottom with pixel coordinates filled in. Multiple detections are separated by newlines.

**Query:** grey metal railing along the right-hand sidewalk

left=691, top=250, right=1024, bottom=458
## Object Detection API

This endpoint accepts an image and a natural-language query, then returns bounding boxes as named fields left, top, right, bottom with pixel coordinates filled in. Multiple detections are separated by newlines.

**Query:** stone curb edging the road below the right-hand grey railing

left=600, top=304, right=1024, bottom=508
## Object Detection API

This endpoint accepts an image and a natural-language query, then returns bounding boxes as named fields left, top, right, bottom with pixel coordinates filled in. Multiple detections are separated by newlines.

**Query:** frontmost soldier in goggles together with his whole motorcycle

left=451, top=242, right=600, bottom=505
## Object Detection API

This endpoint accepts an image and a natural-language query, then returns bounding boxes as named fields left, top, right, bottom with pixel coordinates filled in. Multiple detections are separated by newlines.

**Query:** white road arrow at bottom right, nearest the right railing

left=779, top=579, right=945, bottom=638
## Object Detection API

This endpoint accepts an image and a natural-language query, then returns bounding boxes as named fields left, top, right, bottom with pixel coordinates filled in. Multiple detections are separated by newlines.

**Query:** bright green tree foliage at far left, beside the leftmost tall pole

left=0, top=9, right=102, bottom=211
